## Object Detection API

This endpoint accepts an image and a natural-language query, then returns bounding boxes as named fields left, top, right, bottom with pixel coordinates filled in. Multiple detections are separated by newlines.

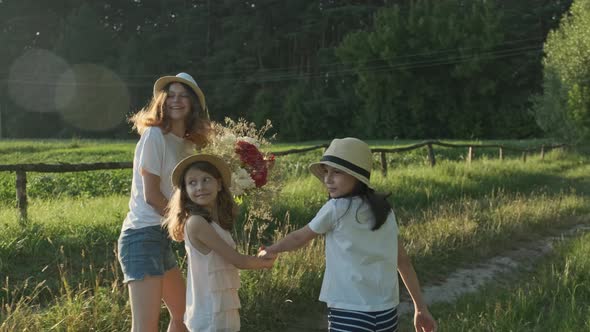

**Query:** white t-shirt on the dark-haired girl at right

left=308, top=197, right=399, bottom=311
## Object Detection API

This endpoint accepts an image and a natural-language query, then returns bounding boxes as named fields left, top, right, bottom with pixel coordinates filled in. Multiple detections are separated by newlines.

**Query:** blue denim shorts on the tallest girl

left=118, top=226, right=178, bottom=282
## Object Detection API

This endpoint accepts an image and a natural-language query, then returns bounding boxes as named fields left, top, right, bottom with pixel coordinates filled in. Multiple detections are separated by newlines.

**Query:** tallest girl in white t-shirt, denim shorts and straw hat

left=118, top=73, right=211, bottom=332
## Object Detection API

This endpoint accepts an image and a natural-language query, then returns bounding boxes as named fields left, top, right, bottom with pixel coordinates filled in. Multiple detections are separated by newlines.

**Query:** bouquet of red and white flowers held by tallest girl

left=203, top=118, right=275, bottom=200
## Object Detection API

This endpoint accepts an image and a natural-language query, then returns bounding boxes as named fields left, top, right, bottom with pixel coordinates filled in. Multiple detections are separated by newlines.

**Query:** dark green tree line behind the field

left=0, top=0, right=587, bottom=141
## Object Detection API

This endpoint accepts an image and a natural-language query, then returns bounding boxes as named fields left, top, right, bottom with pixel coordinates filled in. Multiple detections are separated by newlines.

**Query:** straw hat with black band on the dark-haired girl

left=309, top=137, right=373, bottom=187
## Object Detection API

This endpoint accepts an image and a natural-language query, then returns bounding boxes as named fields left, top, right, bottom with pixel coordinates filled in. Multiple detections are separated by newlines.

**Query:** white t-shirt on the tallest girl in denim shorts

left=122, top=127, right=195, bottom=230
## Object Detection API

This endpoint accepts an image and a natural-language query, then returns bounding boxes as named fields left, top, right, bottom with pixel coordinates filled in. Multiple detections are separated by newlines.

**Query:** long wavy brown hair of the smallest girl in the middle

left=163, top=161, right=238, bottom=242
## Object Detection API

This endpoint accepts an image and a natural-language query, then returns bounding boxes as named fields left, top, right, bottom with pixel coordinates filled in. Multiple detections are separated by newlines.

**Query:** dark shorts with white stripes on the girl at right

left=328, top=308, right=397, bottom=332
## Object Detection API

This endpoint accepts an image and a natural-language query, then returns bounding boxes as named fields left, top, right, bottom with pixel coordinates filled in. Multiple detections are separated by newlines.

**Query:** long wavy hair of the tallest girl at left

left=128, top=82, right=212, bottom=147
